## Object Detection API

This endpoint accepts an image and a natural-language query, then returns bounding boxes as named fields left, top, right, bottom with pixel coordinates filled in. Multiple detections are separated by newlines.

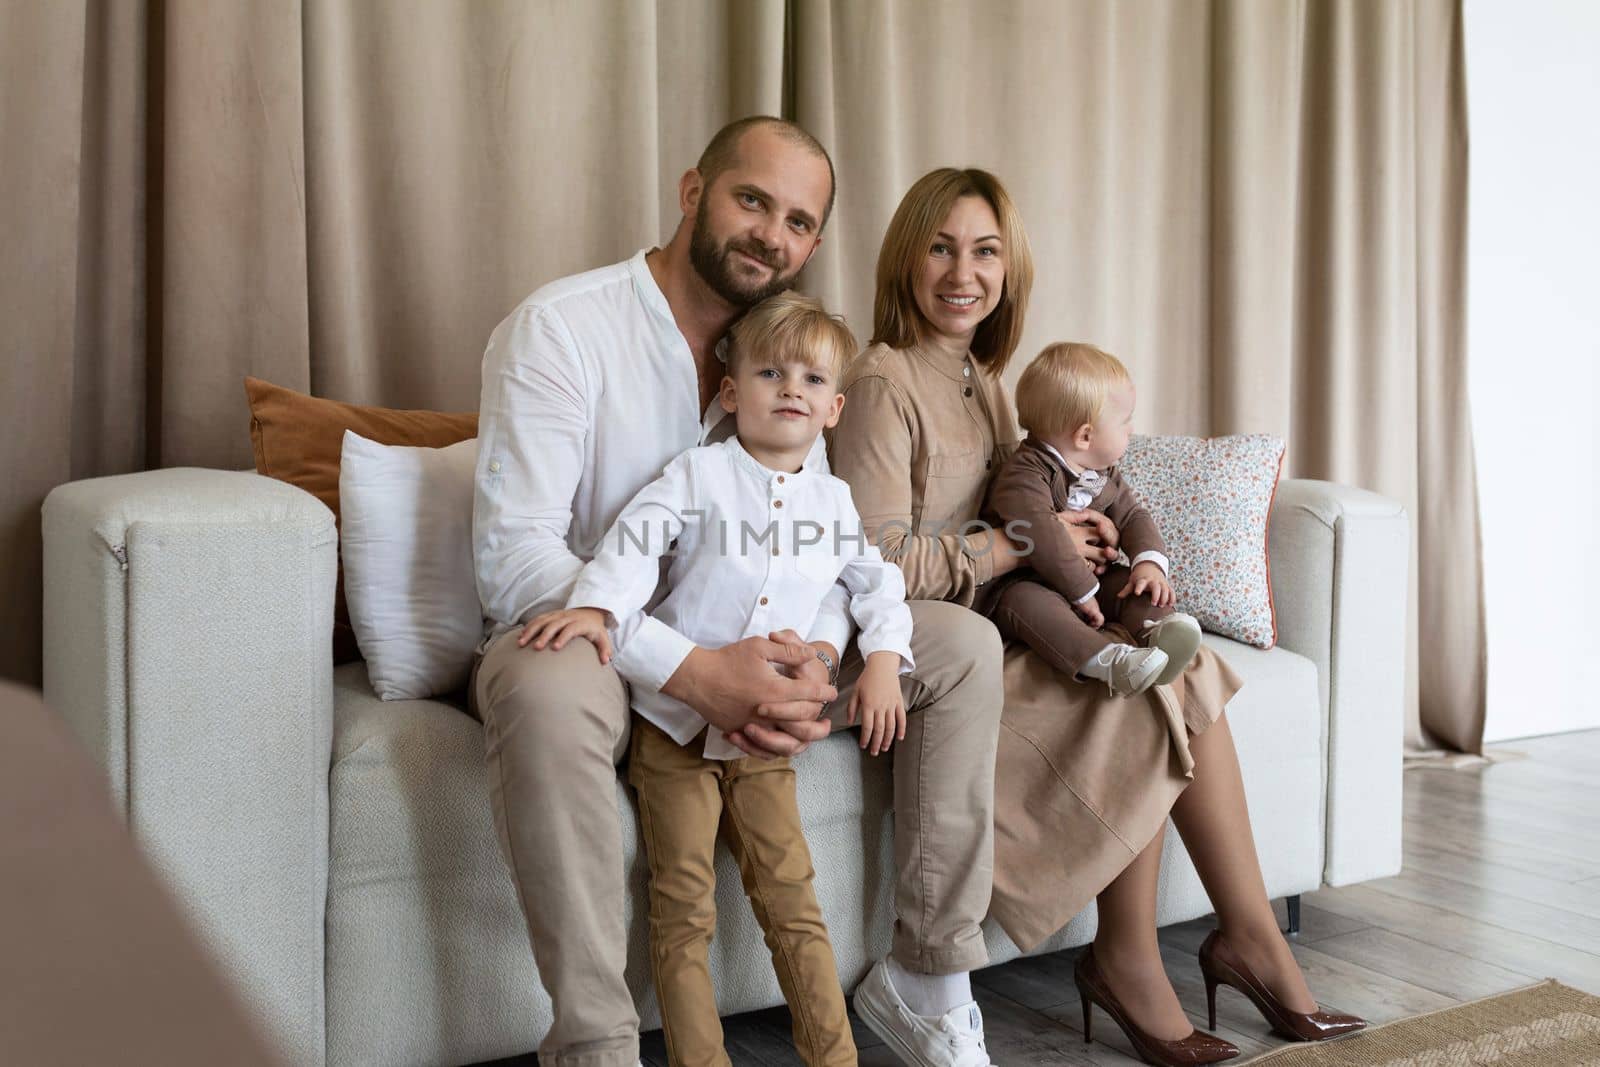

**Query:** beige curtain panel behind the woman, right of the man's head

left=790, top=0, right=1485, bottom=750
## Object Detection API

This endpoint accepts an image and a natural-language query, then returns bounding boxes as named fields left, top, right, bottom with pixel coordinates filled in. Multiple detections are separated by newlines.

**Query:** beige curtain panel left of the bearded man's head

left=0, top=0, right=786, bottom=685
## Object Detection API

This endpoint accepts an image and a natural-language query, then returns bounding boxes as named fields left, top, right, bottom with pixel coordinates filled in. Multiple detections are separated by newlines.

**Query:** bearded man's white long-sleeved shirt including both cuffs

left=472, top=251, right=851, bottom=691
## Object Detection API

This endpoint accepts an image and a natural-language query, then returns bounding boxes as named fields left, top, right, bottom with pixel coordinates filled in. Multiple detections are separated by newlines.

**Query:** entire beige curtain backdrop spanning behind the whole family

left=0, top=0, right=1483, bottom=750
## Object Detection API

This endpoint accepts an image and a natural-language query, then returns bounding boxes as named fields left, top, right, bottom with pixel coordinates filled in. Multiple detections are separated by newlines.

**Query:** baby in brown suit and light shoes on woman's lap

left=989, top=337, right=1200, bottom=696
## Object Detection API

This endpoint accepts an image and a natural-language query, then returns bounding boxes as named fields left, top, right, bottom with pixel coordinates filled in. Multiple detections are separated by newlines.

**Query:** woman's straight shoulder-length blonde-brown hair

left=872, top=166, right=1034, bottom=374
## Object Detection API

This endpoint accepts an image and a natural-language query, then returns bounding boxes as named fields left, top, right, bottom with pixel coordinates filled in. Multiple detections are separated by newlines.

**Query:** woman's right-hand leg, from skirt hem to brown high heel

left=1173, top=713, right=1317, bottom=1011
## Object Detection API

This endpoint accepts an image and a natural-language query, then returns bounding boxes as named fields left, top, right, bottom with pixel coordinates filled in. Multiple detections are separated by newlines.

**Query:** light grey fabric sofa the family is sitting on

left=43, top=469, right=1408, bottom=1067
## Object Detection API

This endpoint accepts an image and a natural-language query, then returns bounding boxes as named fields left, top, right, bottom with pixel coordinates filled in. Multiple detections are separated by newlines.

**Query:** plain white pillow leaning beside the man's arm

left=339, top=430, right=483, bottom=701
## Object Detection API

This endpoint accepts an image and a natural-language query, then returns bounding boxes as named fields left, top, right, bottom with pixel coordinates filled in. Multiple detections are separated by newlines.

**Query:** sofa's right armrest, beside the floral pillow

left=1267, top=478, right=1411, bottom=885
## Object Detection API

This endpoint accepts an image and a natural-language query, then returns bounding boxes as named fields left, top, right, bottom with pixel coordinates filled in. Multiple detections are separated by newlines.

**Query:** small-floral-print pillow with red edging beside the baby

left=1120, top=434, right=1283, bottom=648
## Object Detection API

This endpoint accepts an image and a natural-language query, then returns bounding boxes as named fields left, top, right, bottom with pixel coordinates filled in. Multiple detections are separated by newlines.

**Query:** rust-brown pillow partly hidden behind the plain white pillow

left=245, top=378, right=478, bottom=664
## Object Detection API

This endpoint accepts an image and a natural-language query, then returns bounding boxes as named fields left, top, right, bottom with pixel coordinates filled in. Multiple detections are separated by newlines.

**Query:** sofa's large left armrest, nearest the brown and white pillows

left=43, top=469, right=338, bottom=1064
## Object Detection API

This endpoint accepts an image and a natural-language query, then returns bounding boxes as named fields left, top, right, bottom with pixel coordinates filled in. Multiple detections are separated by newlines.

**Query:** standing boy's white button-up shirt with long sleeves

left=566, top=437, right=912, bottom=760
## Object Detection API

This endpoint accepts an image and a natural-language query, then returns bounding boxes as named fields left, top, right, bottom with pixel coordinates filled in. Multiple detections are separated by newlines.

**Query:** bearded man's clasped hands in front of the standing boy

left=661, top=637, right=838, bottom=758
